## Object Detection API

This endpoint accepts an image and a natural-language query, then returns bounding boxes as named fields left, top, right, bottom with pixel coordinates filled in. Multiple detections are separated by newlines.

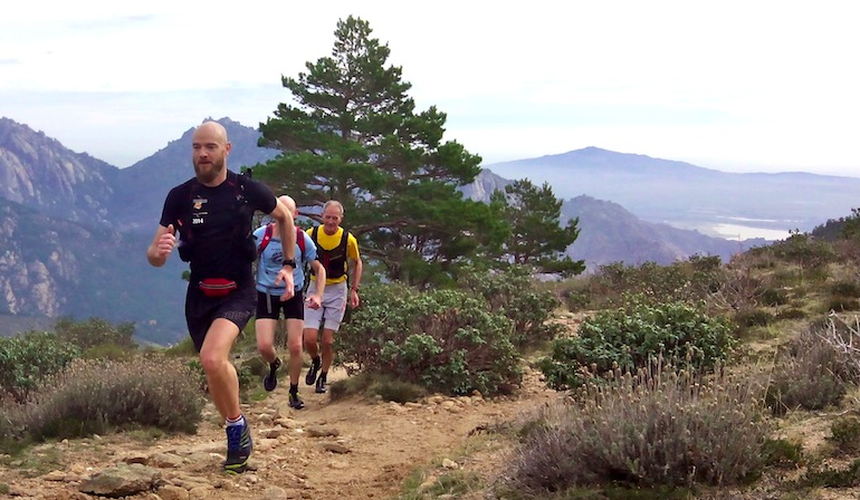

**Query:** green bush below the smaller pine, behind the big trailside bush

left=459, top=266, right=561, bottom=349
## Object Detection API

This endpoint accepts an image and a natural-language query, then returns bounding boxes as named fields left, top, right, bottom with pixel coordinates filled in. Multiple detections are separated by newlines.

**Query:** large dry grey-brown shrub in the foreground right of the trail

left=497, top=367, right=770, bottom=498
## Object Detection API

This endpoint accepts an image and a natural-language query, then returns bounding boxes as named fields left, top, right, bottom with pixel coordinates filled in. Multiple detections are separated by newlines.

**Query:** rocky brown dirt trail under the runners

left=0, top=364, right=559, bottom=500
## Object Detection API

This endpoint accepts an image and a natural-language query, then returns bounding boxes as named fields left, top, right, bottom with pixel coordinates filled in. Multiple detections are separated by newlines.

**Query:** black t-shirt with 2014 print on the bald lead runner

left=156, top=170, right=277, bottom=285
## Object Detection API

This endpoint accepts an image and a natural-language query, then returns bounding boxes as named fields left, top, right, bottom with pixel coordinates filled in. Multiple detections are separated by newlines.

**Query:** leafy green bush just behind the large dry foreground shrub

left=538, top=296, right=736, bottom=390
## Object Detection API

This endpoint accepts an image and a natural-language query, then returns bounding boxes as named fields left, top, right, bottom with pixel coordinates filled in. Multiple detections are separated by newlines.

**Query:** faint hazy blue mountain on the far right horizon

left=487, top=147, right=860, bottom=236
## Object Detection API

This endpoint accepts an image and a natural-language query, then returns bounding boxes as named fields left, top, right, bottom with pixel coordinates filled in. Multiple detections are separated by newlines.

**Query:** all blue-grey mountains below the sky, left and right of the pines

left=0, top=118, right=848, bottom=343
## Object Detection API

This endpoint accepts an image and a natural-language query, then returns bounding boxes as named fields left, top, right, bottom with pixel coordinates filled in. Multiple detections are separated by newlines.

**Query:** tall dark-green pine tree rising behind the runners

left=254, top=16, right=501, bottom=284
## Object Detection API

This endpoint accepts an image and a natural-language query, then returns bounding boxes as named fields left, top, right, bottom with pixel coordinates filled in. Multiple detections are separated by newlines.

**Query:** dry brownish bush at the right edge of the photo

left=767, top=319, right=860, bottom=415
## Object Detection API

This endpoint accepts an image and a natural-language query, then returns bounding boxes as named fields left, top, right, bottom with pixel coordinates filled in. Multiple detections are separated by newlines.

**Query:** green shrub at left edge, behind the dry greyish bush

left=0, top=332, right=81, bottom=402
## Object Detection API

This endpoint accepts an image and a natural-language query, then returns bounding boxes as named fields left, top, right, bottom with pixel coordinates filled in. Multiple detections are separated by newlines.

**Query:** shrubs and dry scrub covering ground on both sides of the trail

left=5, top=225, right=860, bottom=499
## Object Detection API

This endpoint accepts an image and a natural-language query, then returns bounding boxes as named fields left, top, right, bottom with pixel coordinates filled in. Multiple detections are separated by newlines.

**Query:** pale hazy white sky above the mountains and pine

left=0, top=0, right=860, bottom=176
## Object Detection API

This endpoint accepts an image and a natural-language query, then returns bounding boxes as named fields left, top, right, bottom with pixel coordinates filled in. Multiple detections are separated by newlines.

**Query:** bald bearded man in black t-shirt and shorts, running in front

left=146, top=121, right=296, bottom=473
